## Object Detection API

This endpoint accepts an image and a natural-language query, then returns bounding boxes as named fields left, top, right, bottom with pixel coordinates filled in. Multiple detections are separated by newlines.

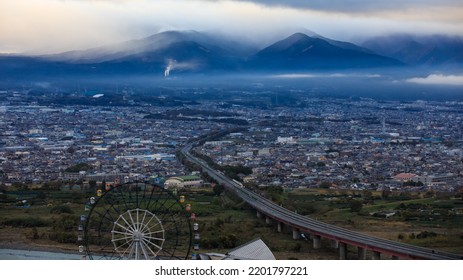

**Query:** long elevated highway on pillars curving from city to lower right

left=181, top=143, right=463, bottom=260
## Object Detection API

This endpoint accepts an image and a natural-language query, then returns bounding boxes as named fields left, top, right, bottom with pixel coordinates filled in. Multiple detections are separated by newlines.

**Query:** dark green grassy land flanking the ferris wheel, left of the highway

left=0, top=189, right=336, bottom=259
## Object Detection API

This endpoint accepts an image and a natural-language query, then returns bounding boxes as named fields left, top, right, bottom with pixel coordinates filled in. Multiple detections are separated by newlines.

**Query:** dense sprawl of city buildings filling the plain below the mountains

left=0, top=90, right=463, bottom=191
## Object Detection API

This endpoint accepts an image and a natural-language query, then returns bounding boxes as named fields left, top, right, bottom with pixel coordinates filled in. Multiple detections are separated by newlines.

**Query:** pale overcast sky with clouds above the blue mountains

left=0, top=0, right=463, bottom=53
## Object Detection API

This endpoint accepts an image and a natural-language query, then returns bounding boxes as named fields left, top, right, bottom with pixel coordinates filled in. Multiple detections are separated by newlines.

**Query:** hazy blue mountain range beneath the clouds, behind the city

left=0, top=31, right=463, bottom=78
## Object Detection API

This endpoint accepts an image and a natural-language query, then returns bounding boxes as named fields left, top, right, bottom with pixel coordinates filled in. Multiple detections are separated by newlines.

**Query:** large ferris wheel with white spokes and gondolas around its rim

left=81, top=182, right=192, bottom=260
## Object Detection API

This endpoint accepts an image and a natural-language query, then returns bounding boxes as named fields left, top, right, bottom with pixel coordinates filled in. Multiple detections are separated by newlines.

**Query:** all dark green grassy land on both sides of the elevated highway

left=0, top=185, right=463, bottom=259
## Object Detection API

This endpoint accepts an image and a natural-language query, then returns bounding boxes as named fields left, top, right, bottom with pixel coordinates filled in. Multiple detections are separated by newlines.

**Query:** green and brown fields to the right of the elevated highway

left=285, top=189, right=463, bottom=254
